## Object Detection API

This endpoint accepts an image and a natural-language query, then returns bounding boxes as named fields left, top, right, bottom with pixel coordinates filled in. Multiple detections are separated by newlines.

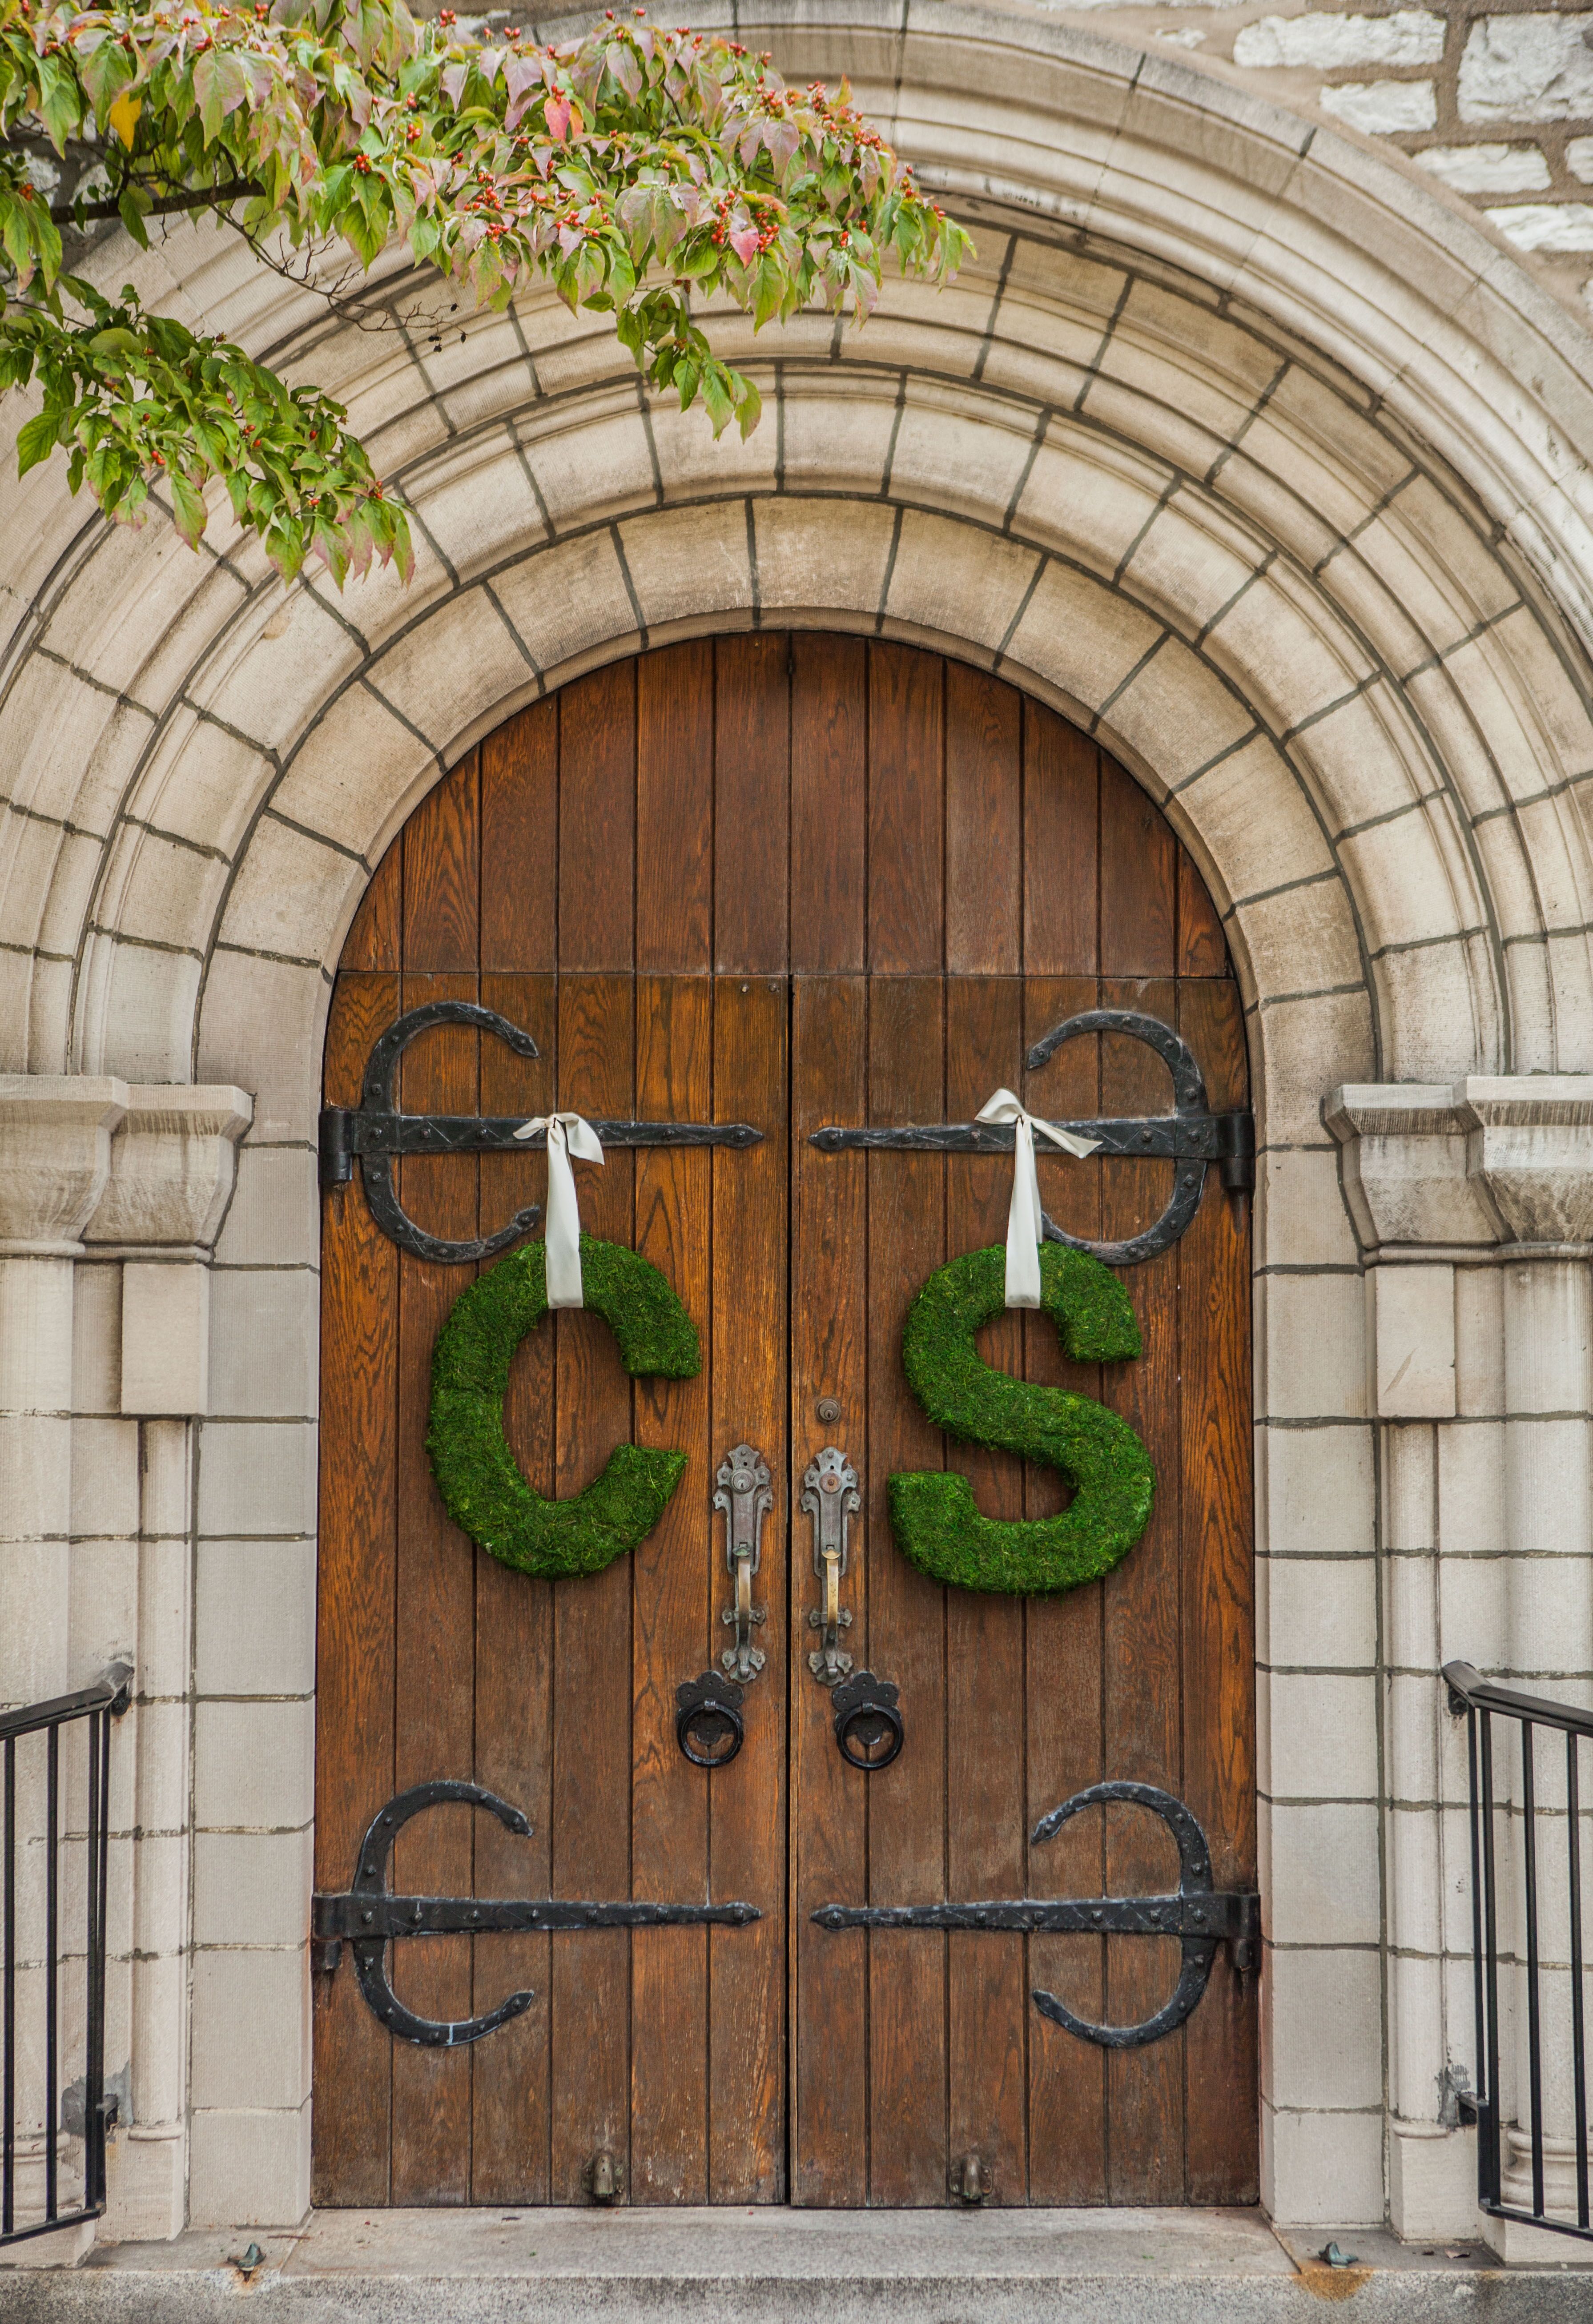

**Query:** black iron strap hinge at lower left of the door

left=309, top=1780, right=763, bottom=2050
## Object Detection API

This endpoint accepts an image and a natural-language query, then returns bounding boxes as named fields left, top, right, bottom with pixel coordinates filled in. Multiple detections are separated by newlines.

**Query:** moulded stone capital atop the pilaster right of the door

left=1323, top=1074, right=1593, bottom=1257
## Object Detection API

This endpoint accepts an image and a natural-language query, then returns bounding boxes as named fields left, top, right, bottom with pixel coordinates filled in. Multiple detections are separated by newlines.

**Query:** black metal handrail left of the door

left=0, top=1662, right=133, bottom=2245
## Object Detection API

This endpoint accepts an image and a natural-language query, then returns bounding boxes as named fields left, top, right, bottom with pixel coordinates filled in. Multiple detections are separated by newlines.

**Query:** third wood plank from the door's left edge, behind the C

left=470, top=962, right=558, bottom=2203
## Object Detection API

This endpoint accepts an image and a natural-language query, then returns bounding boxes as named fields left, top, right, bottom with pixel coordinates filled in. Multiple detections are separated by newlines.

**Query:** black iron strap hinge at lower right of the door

left=814, top=1782, right=1260, bottom=2050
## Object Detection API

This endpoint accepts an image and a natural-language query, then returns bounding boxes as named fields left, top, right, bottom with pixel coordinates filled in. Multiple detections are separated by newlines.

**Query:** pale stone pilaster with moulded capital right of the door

left=1323, top=1076, right=1593, bottom=2256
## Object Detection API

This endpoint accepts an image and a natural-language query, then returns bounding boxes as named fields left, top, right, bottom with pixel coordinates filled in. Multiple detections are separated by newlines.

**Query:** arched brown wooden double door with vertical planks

left=314, top=635, right=1256, bottom=2205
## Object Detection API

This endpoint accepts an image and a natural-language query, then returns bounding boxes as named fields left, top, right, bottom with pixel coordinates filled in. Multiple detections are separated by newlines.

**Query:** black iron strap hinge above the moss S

left=809, top=1009, right=1256, bottom=1267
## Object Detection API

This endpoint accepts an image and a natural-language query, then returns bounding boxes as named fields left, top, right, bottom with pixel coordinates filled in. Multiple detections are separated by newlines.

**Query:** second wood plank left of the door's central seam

left=630, top=971, right=719, bottom=2203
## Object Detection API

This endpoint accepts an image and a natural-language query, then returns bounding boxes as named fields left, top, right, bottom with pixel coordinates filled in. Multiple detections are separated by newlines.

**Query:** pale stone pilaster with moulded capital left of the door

left=0, top=1074, right=251, bottom=2238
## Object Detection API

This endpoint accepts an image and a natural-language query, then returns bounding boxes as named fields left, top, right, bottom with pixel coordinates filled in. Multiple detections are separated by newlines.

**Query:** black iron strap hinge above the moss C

left=321, top=1001, right=763, bottom=1267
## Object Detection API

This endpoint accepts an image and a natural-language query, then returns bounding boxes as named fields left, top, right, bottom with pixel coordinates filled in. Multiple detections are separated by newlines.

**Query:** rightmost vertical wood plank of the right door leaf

left=1177, top=978, right=1258, bottom=2203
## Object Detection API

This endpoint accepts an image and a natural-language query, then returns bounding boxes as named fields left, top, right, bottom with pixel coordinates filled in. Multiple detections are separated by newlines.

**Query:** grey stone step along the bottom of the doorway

left=0, top=2208, right=1593, bottom=2324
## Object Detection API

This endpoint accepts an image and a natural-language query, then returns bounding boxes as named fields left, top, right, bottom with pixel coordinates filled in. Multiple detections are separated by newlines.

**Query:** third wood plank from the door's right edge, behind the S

left=1023, top=976, right=1107, bottom=2203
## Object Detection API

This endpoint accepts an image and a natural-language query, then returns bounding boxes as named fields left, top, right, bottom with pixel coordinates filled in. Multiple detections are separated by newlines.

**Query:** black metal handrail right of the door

left=1444, top=1662, right=1593, bottom=2240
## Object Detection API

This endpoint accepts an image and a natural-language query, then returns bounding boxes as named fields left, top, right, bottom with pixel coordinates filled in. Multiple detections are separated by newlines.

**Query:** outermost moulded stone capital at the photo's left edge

left=0, top=1074, right=128, bottom=1259
